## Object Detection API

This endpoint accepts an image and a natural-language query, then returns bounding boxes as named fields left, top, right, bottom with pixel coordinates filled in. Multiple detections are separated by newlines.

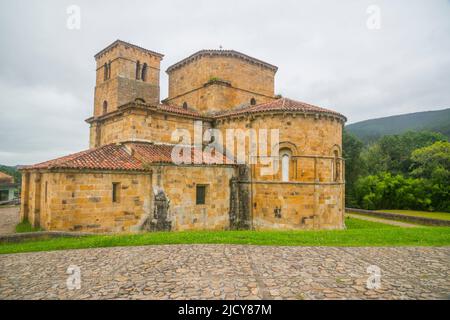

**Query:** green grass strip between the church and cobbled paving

left=0, top=218, right=450, bottom=254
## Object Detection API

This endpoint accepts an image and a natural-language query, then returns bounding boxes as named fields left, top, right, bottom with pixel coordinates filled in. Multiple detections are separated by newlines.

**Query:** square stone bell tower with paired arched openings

left=94, top=40, right=163, bottom=118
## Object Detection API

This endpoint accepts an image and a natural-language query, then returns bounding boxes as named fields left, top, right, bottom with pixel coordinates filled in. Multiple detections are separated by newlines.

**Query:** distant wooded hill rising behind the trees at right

left=346, top=108, right=450, bottom=143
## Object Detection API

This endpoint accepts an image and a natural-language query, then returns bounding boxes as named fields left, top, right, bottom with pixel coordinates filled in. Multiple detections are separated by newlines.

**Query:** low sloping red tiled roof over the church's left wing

left=21, top=142, right=232, bottom=171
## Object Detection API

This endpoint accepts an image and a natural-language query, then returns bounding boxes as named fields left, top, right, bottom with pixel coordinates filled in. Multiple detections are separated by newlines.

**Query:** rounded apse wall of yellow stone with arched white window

left=216, top=114, right=345, bottom=229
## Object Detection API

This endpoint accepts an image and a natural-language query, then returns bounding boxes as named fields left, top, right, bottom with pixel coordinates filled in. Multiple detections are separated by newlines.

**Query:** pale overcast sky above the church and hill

left=0, top=0, right=450, bottom=165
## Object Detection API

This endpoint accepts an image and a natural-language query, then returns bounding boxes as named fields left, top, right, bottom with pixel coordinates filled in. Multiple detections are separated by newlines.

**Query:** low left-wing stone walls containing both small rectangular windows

left=21, top=166, right=235, bottom=232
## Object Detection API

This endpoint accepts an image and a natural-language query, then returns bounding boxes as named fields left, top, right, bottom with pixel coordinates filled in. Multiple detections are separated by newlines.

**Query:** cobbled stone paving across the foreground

left=0, top=245, right=450, bottom=299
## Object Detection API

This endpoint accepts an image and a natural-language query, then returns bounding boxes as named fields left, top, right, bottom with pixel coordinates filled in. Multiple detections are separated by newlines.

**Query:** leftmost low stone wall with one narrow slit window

left=21, top=172, right=151, bottom=232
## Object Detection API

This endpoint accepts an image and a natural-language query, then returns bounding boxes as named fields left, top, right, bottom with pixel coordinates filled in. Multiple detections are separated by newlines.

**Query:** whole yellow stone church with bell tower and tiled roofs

left=21, top=40, right=346, bottom=232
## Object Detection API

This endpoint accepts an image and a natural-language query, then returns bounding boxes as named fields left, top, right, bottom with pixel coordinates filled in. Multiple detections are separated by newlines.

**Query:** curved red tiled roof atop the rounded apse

left=215, top=98, right=346, bottom=120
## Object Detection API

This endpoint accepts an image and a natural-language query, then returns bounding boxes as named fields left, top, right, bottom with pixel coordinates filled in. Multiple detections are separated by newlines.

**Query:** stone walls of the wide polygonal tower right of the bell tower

left=167, top=56, right=275, bottom=111
